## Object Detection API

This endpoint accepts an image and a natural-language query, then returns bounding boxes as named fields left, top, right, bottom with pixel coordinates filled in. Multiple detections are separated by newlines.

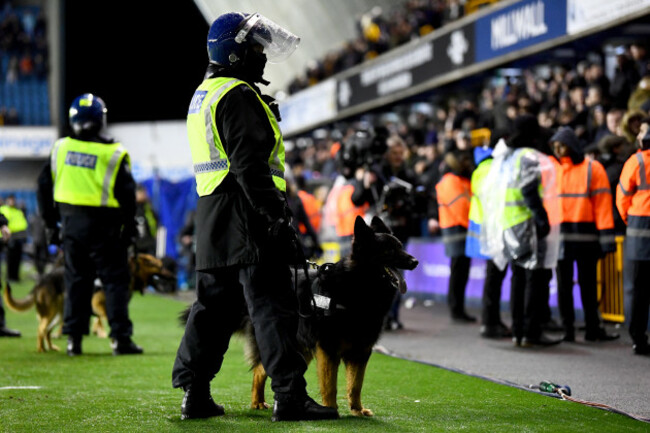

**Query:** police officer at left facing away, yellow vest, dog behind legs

left=38, top=93, right=142, bottom=356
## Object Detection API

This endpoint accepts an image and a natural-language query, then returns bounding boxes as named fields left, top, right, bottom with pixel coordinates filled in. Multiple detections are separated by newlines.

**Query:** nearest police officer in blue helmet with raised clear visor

left=172, top=12, right=338, bottom=421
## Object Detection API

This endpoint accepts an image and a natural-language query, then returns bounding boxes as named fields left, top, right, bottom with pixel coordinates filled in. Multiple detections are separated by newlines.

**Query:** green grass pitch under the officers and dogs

left=0, top=279, right=650, bottom=433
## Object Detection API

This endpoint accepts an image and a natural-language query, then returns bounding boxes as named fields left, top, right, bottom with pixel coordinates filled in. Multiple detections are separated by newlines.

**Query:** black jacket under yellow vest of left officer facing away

left=36, top=133, right=135, bottom=233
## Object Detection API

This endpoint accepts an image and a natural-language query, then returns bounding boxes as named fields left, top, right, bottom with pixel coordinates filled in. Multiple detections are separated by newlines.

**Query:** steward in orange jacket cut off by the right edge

left=616, top=118, right=650, bottom=355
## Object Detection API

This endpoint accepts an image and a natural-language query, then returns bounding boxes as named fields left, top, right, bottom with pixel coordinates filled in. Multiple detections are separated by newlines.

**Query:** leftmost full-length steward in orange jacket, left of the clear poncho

left=436, top=149, right=476, bottom=322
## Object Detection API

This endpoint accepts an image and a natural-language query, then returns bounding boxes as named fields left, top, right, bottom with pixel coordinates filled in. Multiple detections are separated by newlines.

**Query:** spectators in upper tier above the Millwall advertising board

left=287, top=0, right=465, bottom=94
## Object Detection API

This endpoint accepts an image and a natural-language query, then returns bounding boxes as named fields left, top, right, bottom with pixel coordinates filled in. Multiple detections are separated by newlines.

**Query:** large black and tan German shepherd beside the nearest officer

left=185, top=217, right=418, bottom=416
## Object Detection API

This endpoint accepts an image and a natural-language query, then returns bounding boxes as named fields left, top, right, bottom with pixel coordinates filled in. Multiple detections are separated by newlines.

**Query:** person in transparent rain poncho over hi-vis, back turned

left=480, top=115, right=561, bottom=346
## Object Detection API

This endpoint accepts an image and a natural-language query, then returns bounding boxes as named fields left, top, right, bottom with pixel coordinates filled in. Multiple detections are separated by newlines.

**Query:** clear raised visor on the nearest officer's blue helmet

left=235, top=14, right=300, bottom=63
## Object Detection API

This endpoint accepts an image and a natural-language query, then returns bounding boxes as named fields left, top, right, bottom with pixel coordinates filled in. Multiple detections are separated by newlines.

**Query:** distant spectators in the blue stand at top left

left=0, top=0, right=48, bottom=125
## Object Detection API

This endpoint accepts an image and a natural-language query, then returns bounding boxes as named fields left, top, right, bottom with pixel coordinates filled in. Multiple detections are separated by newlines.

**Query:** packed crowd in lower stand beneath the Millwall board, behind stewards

left=280, top=42, right=650, bottom=347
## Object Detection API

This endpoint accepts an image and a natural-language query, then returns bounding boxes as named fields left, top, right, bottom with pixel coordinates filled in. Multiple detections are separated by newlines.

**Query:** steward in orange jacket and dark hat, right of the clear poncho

left=551, top=127, right=619, bottom=342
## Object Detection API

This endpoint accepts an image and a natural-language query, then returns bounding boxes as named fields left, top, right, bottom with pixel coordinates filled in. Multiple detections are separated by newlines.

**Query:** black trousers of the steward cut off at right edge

left=625, top=260, right=650, bottom=346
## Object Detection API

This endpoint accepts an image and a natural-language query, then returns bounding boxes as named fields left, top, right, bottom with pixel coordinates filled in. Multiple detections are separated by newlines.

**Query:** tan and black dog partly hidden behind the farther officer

left=2, top=253, right=176, bottom=352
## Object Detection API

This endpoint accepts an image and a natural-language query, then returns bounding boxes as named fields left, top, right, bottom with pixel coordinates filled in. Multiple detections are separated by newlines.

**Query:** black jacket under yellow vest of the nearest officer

left=190, top=67, right=287, bottom=271
